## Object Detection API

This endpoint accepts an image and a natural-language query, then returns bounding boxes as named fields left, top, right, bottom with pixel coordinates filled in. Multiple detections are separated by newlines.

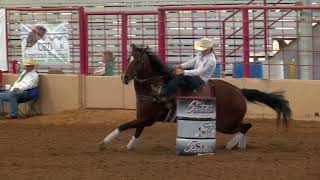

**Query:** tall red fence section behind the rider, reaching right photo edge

left=159, top=6, right=320, bottom=79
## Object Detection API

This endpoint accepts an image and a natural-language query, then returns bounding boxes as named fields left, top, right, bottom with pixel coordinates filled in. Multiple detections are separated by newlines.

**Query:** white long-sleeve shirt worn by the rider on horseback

left=181, top=51, right=217, bottom=82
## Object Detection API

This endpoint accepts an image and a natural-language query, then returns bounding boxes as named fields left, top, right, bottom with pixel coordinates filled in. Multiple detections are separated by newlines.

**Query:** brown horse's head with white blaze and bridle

left=122, top=44, right=152, bottom=84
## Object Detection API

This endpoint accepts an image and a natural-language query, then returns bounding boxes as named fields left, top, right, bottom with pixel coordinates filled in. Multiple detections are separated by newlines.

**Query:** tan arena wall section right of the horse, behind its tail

left=225, top=79, right=320, bottom=121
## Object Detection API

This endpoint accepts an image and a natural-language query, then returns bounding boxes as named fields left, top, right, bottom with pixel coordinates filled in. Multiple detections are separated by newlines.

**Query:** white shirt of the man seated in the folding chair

left=10, top=69, right=39, bottom=91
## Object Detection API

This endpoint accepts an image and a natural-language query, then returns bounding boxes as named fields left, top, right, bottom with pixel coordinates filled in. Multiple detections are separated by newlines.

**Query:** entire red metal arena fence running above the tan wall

left=3, top=5, right=320, bottom=79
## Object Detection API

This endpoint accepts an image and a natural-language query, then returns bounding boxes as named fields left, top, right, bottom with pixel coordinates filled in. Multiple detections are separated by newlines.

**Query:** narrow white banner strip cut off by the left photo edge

left=0, top=9, right=8, bottom=71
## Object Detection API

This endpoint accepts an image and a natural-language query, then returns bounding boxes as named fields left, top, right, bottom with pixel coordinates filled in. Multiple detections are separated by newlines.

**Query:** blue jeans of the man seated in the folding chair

left=0, top=91, right=32, bottom=116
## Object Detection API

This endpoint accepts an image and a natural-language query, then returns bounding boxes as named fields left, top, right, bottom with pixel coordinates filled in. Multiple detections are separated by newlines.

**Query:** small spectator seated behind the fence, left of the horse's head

left=94, top=51, right=115, bottom=76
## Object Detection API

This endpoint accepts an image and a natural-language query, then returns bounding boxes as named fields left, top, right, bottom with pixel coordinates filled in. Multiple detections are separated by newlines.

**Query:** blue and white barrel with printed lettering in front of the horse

left=176, top=97, right=216, bottom=155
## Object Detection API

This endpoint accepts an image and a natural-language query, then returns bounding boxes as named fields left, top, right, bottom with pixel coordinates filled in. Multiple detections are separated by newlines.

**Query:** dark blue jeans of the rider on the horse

left=162, top=75, right=204, bottom=96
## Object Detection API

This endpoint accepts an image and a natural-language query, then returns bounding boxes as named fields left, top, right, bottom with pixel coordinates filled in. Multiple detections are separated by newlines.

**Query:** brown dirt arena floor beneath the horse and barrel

left=0, top=110, right=320, bottom=180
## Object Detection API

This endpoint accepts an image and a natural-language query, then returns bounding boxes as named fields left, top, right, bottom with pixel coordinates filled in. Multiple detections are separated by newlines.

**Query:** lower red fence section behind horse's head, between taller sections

left=86, top=11, right=158, bottom=75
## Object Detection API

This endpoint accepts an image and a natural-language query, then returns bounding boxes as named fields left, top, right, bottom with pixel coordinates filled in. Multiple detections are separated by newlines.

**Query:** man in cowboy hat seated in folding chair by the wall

left=0, top=59, right=39, bottom=119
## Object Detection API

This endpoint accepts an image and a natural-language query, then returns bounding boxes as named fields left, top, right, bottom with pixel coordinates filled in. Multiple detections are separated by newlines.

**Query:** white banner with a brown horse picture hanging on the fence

left=21, top=23, right=70, bottom=65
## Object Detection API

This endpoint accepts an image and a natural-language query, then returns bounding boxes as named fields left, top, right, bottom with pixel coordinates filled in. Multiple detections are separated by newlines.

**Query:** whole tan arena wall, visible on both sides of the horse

left=3, top=74, right=320, bottom=121
